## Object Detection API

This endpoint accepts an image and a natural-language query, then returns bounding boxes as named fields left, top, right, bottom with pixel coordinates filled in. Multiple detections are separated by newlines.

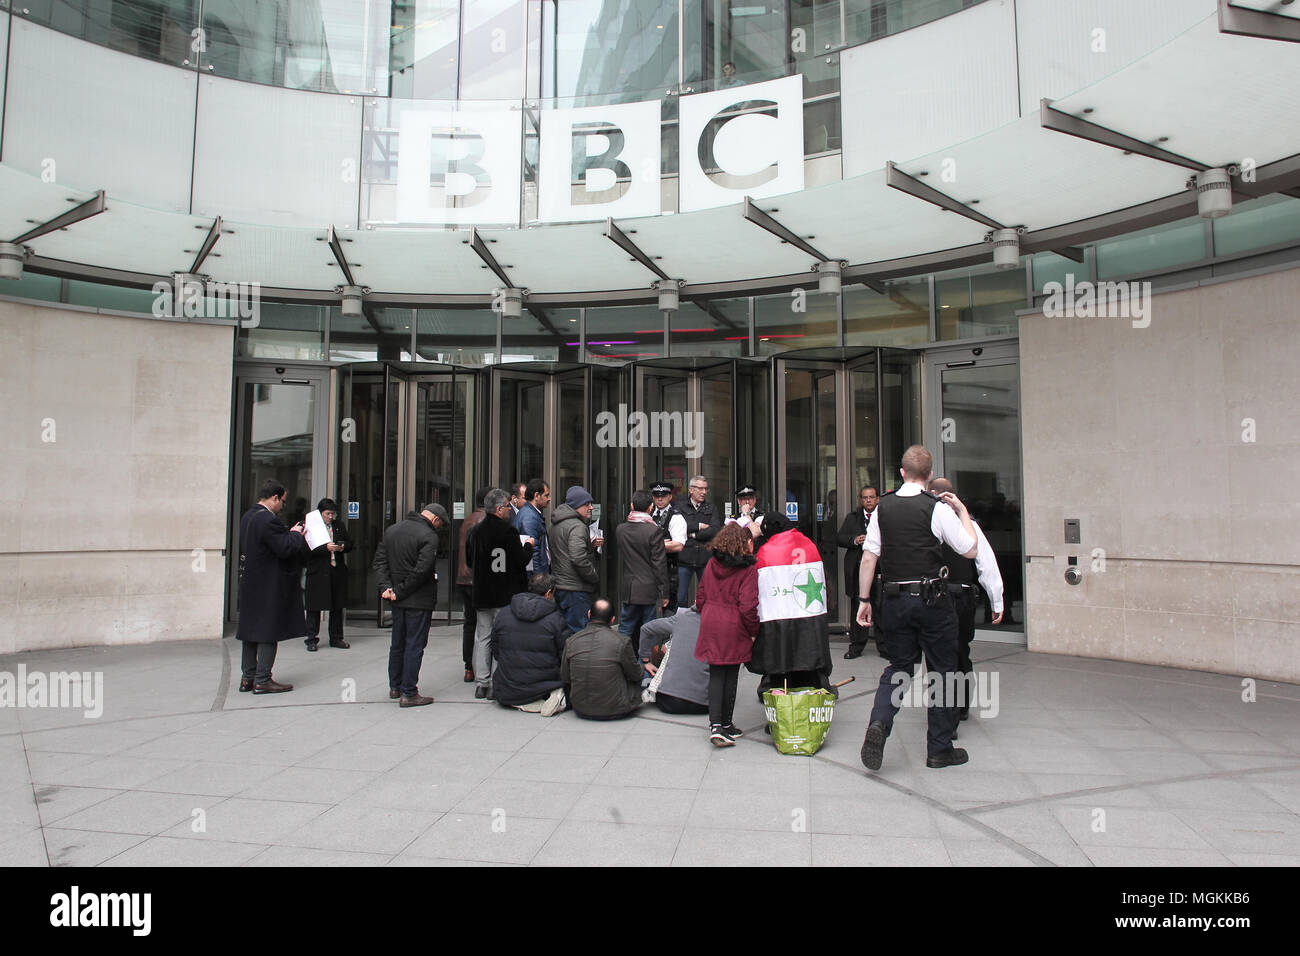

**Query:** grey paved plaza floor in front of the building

left=0, top=627, right=1300, bottom=866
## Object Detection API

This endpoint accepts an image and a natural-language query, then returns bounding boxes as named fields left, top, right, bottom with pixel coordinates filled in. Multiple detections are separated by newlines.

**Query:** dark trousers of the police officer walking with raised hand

left=871, top=594, right=957, bottom=757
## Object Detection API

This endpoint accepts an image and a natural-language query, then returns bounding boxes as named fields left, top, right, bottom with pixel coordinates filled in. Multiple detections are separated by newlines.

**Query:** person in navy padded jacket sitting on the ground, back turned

left=490, top=574, right=568, bottom=717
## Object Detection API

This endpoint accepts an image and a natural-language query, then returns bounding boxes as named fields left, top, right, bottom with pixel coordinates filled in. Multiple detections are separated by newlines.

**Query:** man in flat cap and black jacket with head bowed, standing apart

left=374, top=505, right=449, bottom=708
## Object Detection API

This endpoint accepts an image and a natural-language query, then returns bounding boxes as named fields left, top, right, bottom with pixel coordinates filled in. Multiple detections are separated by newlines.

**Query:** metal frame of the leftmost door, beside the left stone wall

left=222, top=360, right=333, bottom=623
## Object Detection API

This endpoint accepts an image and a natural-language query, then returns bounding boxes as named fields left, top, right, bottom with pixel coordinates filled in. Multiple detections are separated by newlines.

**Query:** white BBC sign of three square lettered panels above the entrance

left=398, top=75, right=803, bottom=225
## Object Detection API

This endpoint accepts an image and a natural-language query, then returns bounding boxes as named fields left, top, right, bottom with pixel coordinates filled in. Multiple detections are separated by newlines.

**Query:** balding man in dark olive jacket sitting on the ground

left=560, top=597, right=642, bottom=721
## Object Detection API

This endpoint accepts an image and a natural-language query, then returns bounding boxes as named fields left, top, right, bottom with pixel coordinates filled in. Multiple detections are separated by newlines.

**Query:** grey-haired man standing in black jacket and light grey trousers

left=465, top=488, right=534, bottom=700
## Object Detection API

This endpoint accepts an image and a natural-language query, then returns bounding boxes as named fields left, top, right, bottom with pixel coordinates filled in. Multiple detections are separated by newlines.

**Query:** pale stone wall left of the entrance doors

left=0, top=302, right=234, bottom=654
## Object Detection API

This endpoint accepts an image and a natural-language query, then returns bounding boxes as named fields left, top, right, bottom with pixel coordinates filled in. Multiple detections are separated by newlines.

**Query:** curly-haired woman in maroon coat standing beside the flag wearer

left=696, top=524, right=758, bottom=747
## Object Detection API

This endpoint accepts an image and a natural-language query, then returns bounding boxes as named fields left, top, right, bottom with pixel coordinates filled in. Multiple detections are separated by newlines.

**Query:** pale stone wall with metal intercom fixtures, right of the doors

left=1021, top=269, right=1300, bottom=682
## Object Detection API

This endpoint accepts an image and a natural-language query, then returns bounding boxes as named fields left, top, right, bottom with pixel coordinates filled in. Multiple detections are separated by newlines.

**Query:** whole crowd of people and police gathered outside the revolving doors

left=238, top=446, right=1002, bottom=769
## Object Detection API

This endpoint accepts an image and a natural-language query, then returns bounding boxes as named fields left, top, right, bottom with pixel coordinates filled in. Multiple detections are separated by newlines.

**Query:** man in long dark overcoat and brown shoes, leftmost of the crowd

left=235, top=479, right=308, bottom=693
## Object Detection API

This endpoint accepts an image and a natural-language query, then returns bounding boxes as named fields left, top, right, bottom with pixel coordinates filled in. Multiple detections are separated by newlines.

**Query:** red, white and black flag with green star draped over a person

left=746, top=529, right=832, bottom=675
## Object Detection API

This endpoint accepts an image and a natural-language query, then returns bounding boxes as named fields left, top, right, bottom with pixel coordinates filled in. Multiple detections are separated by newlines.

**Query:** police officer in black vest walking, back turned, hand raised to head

left=858, top=445, right=976, bottom=770
